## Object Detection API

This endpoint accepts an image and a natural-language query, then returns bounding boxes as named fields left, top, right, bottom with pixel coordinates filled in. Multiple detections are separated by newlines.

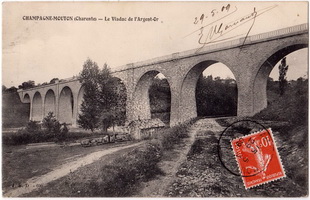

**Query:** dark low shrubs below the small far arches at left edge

left=2, top=112, right=69, bottom=145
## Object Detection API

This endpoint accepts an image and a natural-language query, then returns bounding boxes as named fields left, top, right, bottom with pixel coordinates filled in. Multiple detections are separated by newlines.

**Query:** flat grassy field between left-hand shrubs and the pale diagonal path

left=2, top=141, right=133, bottom=190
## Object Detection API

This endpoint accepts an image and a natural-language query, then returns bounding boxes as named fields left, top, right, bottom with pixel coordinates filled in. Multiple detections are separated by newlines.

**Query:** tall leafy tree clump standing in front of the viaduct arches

left=78, top=59, right=126, bottom=132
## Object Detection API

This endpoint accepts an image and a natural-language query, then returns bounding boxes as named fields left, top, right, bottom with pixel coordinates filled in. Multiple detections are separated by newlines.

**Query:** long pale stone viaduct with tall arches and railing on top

left=18, top=24, right=308, bottom=126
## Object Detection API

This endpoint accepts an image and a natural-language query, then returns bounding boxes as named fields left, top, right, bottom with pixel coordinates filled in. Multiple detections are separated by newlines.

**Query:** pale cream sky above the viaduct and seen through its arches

left=2, top=2, right=308, bottom=87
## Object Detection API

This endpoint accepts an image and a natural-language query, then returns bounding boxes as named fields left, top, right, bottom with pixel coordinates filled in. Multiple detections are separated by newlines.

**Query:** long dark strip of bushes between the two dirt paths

left=88, top=119, right=196, bottom=197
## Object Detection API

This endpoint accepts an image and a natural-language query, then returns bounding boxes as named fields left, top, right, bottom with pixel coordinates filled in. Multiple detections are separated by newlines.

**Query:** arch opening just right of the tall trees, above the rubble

left=133, top=70, right=171, bottom=125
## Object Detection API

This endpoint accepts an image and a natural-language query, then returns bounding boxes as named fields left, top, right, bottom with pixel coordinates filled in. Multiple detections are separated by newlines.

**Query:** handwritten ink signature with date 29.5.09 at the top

left=189, top=4, right=277, bottom=51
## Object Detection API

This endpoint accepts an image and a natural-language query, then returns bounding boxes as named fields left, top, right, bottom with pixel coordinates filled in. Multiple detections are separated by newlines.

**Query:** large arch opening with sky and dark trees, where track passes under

left=180, top=60, right=238, bottom=121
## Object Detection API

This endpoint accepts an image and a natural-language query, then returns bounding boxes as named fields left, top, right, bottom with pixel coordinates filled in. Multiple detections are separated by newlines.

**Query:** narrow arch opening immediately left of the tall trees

left=59, top=87, right=74, bottom=124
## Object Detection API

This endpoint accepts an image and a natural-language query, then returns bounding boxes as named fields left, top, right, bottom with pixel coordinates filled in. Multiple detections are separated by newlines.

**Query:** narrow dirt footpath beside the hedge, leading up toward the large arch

left=135, top=119, right=223, bottom=197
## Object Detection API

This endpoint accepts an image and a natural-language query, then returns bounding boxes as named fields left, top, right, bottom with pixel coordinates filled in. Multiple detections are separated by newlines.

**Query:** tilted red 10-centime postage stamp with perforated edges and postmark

left=231, top=129, right=285, bottom=189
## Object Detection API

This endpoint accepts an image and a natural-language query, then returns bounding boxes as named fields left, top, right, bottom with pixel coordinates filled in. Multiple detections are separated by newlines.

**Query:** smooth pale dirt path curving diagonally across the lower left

left=3, top=142, right=142, bottom=197
